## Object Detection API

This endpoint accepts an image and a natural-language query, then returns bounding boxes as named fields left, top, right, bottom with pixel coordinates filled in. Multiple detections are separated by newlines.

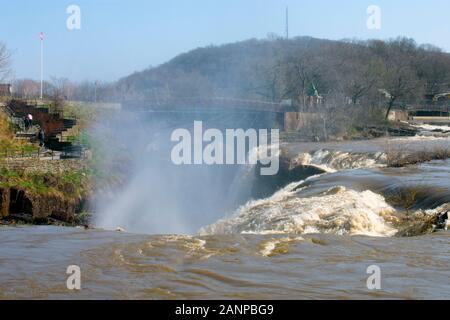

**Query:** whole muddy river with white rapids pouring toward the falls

left=0, top=124, right=450, bottom=299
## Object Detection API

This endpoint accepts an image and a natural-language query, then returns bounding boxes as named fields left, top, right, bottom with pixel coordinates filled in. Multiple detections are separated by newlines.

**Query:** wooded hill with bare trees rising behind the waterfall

left=103, top=37, right=450, bottom=112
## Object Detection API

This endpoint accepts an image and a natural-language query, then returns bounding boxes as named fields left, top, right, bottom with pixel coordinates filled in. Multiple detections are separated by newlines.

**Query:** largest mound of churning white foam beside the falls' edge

left=200, top=186, right=397, bottom=237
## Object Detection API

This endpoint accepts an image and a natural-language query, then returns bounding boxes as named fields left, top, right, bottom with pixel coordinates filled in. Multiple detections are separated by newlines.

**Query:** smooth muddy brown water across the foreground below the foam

left=0, top=227, right=450, bottom=299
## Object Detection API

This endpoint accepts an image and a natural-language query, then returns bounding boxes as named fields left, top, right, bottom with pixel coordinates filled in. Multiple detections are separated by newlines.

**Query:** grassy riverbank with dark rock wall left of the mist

left=0, top=101, right=97, bottom=226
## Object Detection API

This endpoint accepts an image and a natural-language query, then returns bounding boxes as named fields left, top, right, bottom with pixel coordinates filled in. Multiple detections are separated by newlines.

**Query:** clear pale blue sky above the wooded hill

left=0, top=0, right=450, bottom=81
